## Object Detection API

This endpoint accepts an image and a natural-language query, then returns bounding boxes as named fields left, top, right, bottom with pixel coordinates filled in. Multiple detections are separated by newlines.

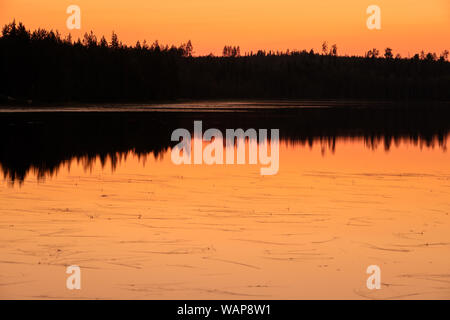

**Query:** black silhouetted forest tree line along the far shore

left=0, top=21, right=450, bottom=103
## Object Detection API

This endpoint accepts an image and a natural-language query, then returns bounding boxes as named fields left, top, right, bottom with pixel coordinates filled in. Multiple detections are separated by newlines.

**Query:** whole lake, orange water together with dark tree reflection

left=0, top=103, right=450, bottom=299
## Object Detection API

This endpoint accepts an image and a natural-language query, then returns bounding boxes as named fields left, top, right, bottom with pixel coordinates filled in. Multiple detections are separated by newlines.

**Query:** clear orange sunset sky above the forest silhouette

left=0, top=0, right=450, bottom=56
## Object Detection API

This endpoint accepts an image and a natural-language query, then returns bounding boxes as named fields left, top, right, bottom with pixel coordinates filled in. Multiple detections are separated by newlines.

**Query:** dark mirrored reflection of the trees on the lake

left=0, top=106, right=450, bottom=183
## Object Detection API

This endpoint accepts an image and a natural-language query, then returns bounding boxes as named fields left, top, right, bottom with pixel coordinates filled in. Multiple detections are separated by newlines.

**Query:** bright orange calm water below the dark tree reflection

left=0, top=131, right=450, bottom=299
